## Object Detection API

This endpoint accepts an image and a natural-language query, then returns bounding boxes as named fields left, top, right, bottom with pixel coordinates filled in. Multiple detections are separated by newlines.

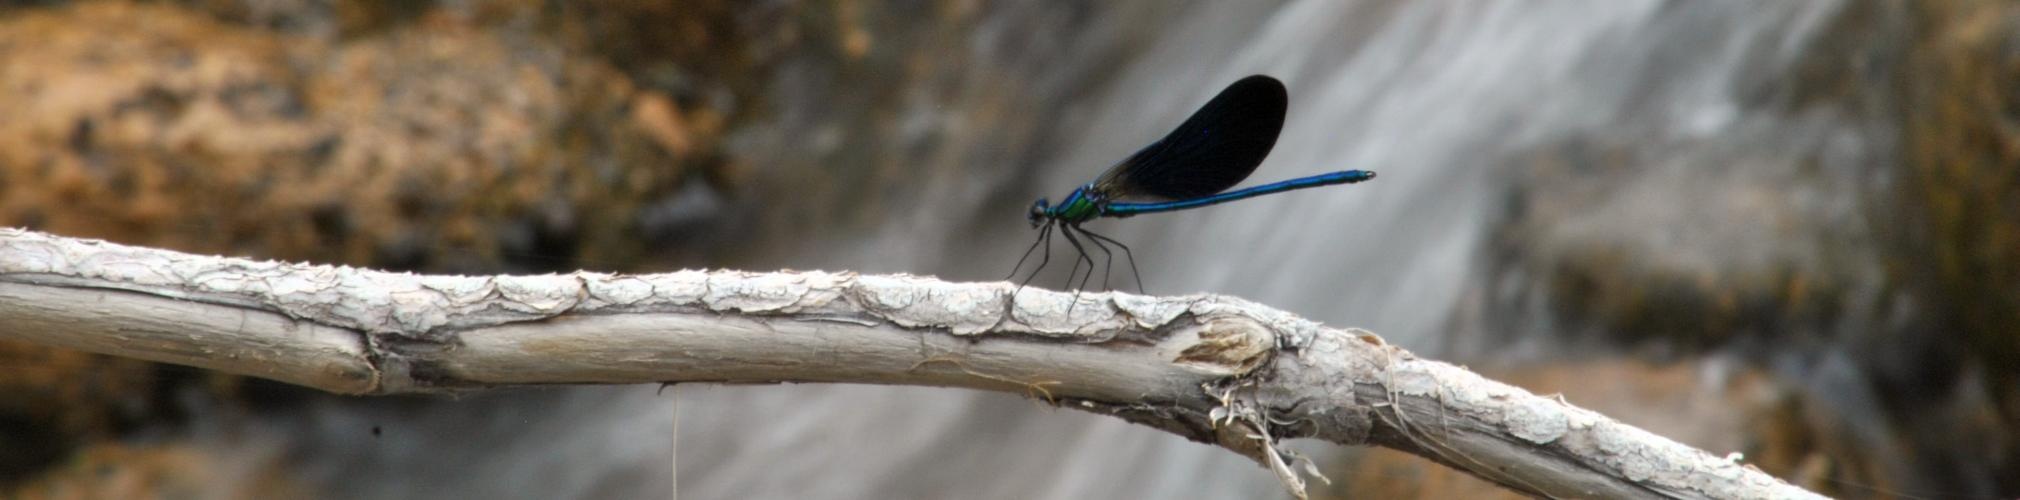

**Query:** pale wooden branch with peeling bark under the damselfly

left=0, top=228, right=1816, bottom=498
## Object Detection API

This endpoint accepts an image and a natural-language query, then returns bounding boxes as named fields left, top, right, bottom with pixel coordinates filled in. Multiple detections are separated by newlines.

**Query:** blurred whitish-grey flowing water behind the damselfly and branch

left=292, top=0, right=1882, bottom=498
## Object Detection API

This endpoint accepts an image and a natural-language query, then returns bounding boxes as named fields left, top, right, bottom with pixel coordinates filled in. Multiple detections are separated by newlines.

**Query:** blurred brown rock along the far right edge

left=1895, top=0, right=2020, bottom=421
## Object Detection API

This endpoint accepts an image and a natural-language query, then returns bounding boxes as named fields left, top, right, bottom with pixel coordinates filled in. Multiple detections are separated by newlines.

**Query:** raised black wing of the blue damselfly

left=1095, top=75, right=1289, bottom=200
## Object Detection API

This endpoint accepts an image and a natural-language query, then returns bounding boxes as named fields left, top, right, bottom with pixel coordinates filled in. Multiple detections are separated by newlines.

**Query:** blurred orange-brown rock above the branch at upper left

left=0, top=4, right=723, bottom=272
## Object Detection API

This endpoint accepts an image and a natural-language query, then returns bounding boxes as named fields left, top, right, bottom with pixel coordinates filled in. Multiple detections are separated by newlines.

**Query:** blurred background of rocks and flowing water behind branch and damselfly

left=0, top=0, right=2020, bottom=498
